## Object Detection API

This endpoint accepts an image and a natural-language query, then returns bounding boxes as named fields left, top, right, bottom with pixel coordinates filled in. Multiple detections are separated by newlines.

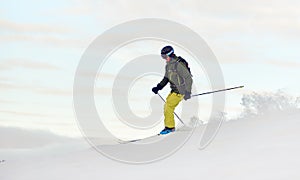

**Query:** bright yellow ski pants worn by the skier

left=164, top=92, right=184, bottom=128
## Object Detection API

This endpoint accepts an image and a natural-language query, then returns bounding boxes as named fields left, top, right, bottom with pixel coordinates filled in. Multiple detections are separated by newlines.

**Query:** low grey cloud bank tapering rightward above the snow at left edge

left=0, top=126, right=73, bottom=149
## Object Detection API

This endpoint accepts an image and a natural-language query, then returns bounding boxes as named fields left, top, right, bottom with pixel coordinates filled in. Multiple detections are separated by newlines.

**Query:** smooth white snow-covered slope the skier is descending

left=0, top=111, right=300, bottom=180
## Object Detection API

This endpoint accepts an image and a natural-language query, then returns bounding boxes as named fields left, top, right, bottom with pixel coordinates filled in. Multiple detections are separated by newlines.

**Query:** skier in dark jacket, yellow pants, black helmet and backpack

left=152, top=46, right=193, bottom=135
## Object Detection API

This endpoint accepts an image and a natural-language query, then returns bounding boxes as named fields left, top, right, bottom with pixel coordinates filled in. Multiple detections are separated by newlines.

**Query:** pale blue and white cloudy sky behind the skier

left=0, top=0, right=300, bottom=136
